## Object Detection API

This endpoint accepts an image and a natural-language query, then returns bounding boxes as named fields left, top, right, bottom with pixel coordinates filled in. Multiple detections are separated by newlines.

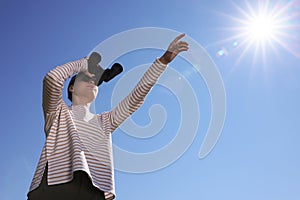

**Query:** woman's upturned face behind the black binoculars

left=71, top=72, right=98, bottom=103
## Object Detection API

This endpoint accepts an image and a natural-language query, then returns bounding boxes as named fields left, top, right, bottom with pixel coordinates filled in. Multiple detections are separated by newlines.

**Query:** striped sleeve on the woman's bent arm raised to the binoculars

left=42, top=58, right=87, bottom=134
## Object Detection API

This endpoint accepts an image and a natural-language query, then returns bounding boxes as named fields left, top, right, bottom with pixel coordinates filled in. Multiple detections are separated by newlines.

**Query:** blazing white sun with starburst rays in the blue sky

left=218, top=0, right=300, bottom=65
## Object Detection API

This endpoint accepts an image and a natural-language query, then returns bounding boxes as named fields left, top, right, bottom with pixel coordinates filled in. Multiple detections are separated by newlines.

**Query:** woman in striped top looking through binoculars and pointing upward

left=28, top=34, right=188, bottom=200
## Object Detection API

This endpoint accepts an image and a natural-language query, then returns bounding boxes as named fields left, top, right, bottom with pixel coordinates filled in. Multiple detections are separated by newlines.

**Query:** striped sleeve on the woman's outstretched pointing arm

left=110, top=59, right=167, bottom=132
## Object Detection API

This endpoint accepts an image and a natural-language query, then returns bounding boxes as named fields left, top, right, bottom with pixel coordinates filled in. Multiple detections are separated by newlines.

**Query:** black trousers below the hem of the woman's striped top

left=27, top=167, right=105, bottom=200
